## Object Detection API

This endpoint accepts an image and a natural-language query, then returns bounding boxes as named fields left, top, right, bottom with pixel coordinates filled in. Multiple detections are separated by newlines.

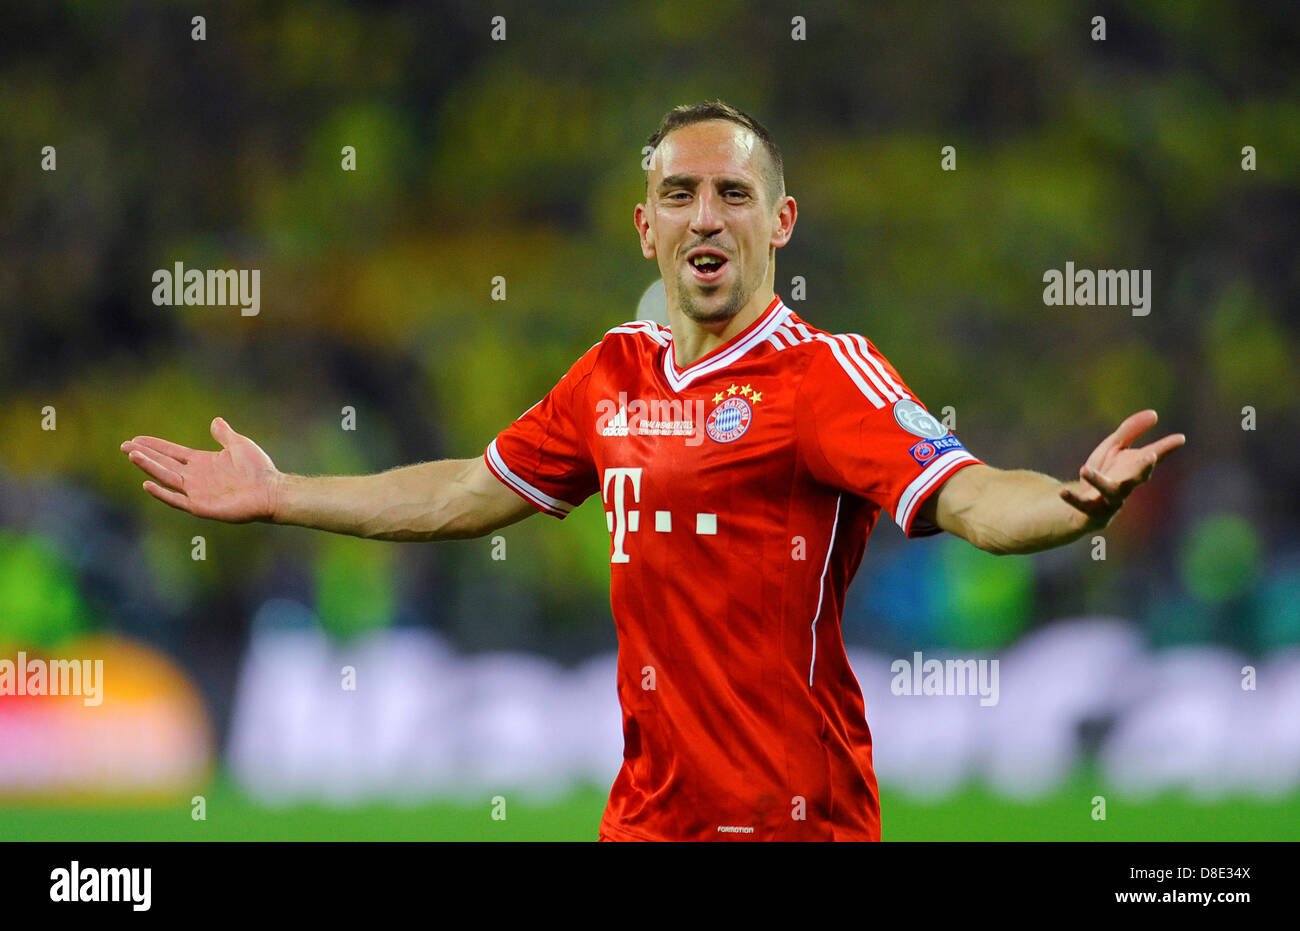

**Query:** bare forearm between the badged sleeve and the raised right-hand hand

left=956, top=468, right=1088, bottom=555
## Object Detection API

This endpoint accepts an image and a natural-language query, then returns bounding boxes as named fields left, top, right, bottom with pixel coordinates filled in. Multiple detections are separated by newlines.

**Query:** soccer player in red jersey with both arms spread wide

left=122, top=101, right=1184, bottom=840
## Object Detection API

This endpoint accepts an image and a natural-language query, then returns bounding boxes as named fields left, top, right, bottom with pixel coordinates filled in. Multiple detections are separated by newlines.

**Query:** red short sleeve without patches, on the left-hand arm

left=484, top=343, right=601, bottom=519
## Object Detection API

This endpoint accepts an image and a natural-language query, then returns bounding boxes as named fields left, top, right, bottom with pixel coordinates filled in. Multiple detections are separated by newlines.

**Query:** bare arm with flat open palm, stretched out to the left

left=121, top=417, right=536, bottom=540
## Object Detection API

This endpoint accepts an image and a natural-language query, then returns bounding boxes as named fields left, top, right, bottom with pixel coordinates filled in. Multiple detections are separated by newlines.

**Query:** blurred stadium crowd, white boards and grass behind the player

left=0, top=0, right=1300, bottom=840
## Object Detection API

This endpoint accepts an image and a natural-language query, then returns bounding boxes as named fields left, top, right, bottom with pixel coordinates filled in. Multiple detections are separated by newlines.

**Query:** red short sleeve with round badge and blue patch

left=797, top=333, right=980, bottom=537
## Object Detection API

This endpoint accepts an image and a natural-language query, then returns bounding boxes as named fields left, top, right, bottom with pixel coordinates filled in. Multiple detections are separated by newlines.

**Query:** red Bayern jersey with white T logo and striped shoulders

left=485, top=296, right=979, bottom=840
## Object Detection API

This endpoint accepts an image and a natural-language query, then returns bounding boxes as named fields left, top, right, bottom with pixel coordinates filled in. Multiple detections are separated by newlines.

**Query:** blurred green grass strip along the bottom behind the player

left=0, top=774, right=1300, bottom=841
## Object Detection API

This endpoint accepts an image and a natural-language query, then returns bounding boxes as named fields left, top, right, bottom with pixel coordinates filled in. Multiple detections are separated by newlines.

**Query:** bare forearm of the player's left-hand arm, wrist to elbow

left=272, top=459, right=481, bottom=541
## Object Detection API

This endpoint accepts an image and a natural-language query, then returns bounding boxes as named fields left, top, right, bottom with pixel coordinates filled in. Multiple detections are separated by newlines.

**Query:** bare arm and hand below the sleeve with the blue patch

left=918, top=411, right=1187, bottom=555
